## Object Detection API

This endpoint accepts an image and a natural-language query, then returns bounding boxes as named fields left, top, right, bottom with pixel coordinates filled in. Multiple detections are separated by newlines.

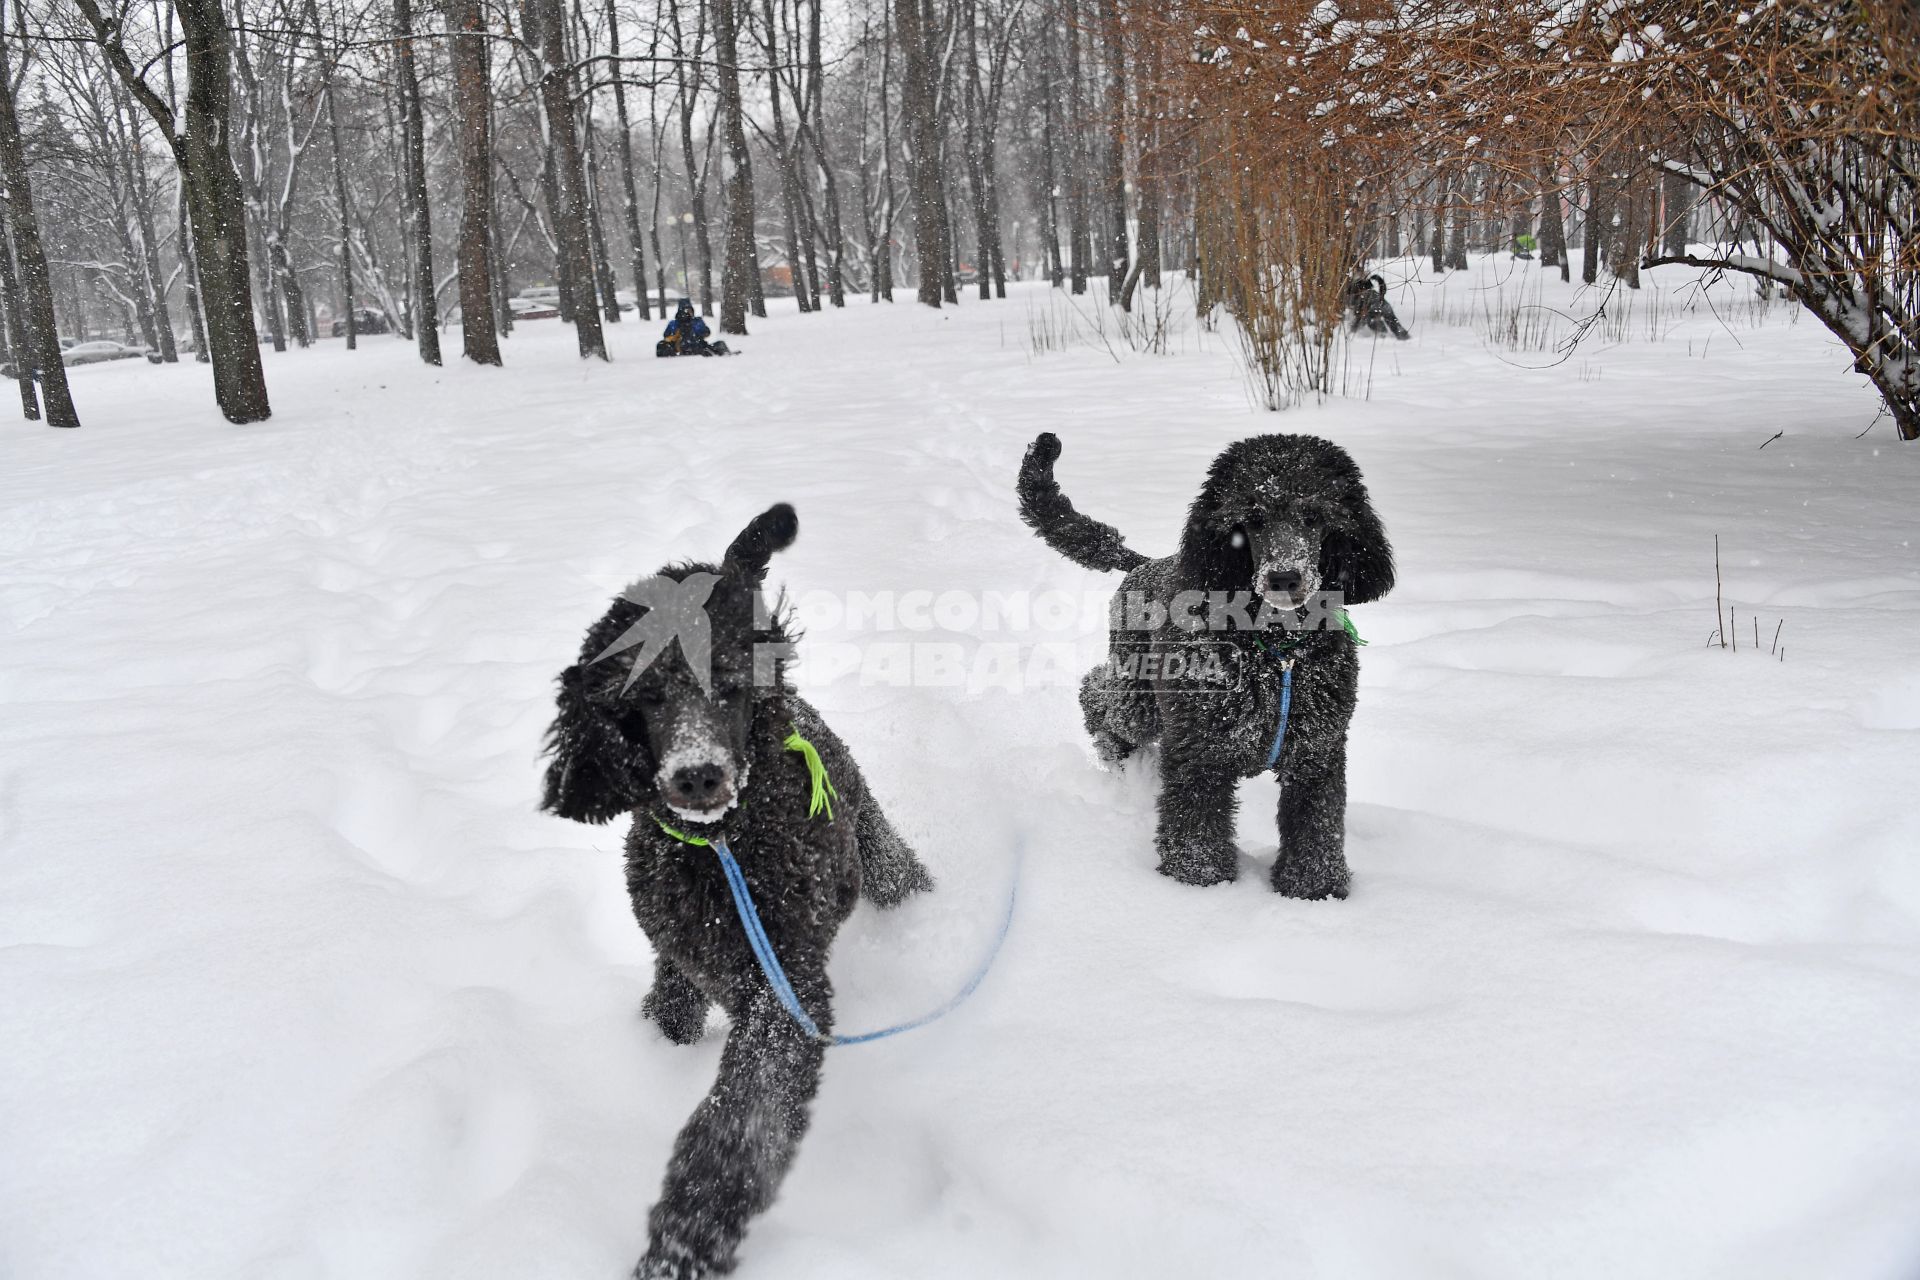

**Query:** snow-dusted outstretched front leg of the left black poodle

left=634, top=969, right=831, bottom=1280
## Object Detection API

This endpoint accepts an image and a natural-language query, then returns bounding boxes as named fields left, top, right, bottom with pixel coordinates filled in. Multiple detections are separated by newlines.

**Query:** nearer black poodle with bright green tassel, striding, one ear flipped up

left=541, top=505, right=933, bottom=1280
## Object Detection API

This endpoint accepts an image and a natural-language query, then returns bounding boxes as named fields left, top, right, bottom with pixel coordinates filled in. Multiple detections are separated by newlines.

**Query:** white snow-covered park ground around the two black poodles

left=0, top=261, right=1920, bottom=1280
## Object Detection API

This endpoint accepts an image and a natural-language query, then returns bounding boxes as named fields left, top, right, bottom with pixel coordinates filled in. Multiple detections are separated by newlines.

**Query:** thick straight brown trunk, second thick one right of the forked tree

left=447, top=0, right=499, bottom=367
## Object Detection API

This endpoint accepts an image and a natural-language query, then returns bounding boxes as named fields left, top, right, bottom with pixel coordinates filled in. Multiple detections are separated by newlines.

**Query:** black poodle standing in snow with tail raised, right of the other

left=1020, top=432, right=1394, bottom=898
